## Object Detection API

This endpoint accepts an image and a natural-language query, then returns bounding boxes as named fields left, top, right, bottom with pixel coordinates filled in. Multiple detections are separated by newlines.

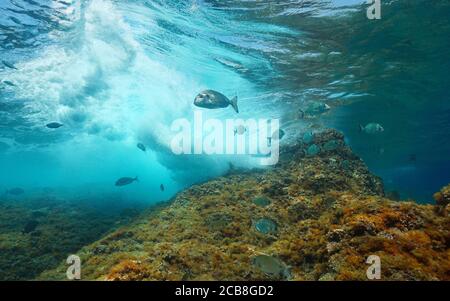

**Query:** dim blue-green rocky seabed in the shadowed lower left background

left=0, top=196, right=144, bottom=281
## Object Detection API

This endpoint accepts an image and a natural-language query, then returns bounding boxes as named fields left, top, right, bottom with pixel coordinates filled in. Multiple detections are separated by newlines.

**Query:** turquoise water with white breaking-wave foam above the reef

left=0, top=0, right=450, bottom=203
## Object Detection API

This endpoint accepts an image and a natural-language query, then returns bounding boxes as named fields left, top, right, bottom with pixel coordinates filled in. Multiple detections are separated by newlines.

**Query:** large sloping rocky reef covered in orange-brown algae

left=39, top=130, right=450, bottom=280
